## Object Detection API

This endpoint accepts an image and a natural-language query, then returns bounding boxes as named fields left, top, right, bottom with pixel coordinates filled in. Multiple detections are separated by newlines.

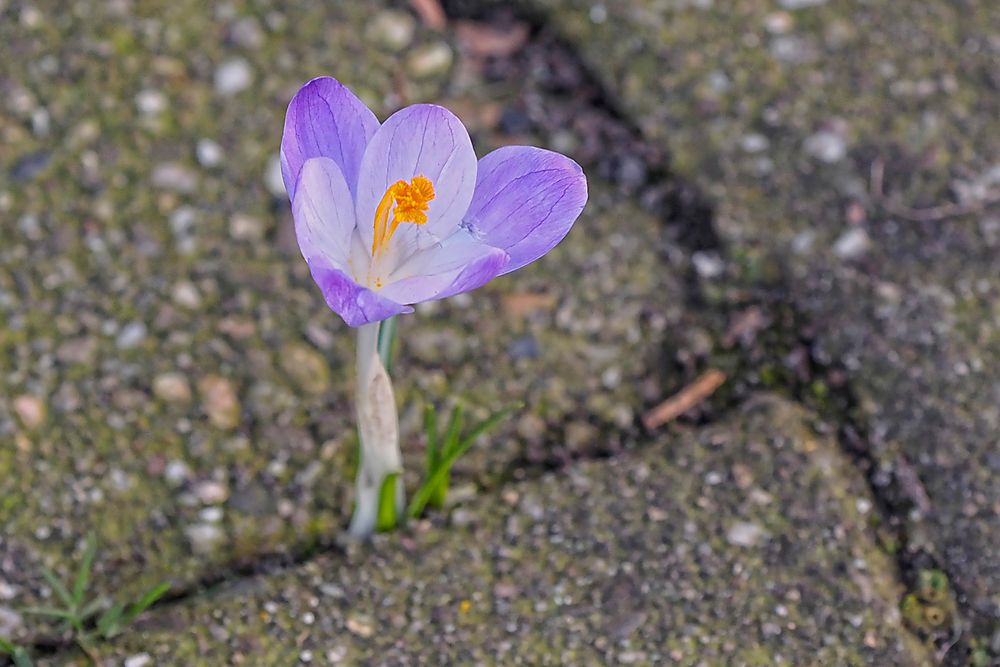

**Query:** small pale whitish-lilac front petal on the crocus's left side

left=292, top=157, right=354, bottom=269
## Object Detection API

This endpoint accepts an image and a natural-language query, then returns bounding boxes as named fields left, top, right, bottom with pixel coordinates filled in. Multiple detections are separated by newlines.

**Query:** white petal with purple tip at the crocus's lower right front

left=379, top=230, right=508, bottom=303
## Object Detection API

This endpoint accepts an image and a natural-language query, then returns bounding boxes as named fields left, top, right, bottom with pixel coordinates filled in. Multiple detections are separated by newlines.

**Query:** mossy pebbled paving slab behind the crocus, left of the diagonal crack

left=0, top=3, right=684, bottom=640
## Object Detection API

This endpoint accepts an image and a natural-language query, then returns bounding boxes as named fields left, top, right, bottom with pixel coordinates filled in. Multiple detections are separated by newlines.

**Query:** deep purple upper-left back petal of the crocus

left=281, top=76, right=378, bottom=201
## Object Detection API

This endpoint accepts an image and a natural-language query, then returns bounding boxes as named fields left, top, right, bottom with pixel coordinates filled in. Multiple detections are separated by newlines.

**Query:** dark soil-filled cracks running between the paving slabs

left=19, top=0, right=975, bottom=664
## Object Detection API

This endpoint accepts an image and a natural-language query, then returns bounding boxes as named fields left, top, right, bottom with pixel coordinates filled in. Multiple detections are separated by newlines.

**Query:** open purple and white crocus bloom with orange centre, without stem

left=281, top=77, right=587, bottom=327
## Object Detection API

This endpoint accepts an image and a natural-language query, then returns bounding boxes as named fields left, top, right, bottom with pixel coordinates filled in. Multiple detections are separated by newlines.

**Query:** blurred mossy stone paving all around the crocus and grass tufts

left=0, top=0, right=1000, bottom=667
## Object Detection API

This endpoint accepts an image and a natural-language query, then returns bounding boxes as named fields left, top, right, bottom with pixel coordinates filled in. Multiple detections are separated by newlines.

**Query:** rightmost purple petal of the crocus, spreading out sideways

left=462, top=146, right=587, bottom=273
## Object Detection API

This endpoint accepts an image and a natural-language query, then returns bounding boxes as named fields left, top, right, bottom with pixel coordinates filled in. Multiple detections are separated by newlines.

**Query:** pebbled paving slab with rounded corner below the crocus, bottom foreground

left=52, top=396, right=929, bottom=665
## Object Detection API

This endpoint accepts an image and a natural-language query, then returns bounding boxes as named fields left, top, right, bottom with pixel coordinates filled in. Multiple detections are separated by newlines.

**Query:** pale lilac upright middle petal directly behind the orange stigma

left=357, top=104, right=476, bottom=253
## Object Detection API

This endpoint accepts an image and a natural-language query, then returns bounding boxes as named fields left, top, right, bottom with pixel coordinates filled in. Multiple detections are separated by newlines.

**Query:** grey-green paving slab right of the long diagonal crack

left=527, top=0, right=1000, bottom=659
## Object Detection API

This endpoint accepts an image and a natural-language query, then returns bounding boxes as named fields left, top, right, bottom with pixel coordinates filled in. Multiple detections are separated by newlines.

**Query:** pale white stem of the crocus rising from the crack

left=350, top=322, right=405, bottom=537
